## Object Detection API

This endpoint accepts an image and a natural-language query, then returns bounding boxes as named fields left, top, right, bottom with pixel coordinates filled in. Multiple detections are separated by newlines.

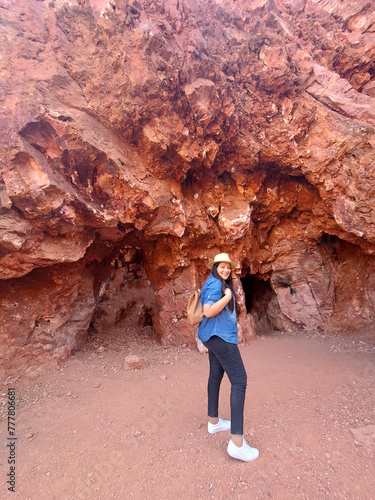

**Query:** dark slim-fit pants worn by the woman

left=203, top=335, right=247, bottom=435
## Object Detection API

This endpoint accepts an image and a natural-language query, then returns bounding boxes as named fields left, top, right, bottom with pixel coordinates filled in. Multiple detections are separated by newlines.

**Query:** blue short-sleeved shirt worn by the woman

left=198, top=274, right=238, bottom=344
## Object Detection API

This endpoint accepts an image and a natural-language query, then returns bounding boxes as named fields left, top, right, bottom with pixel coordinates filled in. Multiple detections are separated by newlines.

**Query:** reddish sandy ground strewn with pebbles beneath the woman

left=0, top=328, right=375, bottom=500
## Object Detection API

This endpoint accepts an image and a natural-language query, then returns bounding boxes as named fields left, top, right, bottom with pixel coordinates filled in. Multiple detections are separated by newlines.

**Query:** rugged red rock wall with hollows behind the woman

left=0, top=0, right=375, bottom=373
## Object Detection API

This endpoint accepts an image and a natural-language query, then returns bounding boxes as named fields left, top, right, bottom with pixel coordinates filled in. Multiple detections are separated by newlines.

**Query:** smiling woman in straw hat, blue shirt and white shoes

left=198, top=253, right=259, bottom=462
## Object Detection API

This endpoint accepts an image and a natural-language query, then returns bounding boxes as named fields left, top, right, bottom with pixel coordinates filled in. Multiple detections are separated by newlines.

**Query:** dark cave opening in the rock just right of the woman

left=241, top=274, right=276, bottom=335
